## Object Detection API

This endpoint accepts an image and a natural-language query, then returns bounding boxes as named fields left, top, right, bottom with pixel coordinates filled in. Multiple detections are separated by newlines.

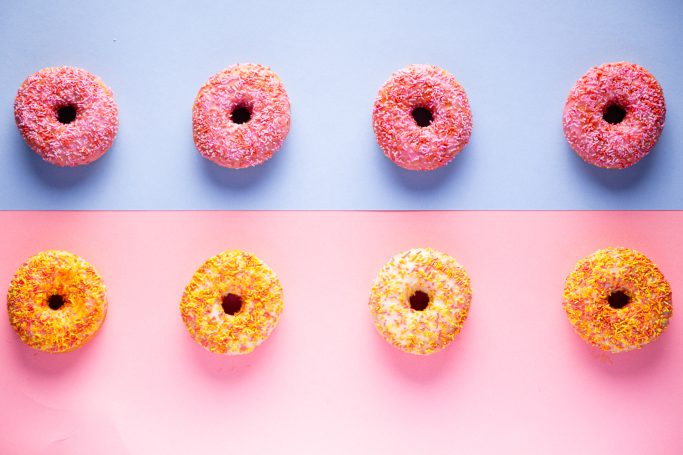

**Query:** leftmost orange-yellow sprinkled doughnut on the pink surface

left=7, top=250, right=107, bottom=352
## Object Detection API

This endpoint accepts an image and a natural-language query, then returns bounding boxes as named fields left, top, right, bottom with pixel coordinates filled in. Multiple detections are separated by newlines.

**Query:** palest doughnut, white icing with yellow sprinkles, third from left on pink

left=370, top=248, right=472, bottom=355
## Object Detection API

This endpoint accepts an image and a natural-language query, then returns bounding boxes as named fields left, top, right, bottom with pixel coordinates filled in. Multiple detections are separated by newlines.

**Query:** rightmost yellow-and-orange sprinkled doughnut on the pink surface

left=564, top=248, right=672, bottom=352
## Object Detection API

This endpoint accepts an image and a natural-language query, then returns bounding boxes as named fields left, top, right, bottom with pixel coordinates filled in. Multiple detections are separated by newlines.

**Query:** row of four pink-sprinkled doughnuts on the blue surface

left=14, top=62, right=666, bottom=171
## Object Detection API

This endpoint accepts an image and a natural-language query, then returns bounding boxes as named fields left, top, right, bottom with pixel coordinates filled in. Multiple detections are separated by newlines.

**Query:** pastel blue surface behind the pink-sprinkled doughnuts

left=0, top=0, right=683, bottom=209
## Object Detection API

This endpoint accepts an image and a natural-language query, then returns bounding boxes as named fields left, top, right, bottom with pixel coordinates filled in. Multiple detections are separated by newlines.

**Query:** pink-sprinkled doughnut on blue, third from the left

left=372, top=65, right=472, bottom=171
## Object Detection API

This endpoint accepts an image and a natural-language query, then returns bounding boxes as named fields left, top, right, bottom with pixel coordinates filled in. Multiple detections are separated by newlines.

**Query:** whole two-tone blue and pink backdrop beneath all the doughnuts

left=0, top=0, right=683, bottom=455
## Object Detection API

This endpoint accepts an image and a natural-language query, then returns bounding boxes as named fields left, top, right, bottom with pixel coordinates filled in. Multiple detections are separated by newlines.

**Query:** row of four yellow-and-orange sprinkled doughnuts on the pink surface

left=7, top=248, right=672, bottom=355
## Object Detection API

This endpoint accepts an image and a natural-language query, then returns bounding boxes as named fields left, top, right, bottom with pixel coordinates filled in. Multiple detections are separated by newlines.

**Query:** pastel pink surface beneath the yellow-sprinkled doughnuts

left=0, top=212, right=683, bottom=454
